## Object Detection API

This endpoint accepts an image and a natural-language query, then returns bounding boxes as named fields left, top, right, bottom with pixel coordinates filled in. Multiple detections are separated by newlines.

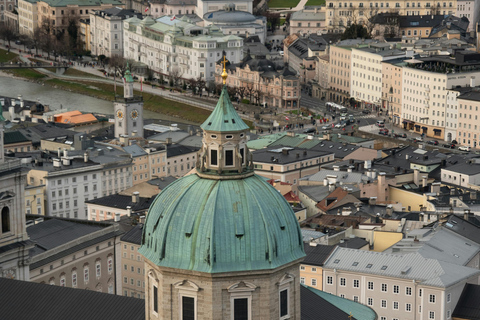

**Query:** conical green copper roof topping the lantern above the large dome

left=201, top=86, right=249, bottom=132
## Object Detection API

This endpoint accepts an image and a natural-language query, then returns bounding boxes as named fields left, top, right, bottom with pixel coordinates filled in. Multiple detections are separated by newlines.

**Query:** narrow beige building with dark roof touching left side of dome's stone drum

left=117, top=223, right=145, bottom=299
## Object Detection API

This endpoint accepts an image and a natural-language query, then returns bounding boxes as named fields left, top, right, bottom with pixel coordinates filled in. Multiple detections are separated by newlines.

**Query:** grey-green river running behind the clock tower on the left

left=0, top=75, right=198, bottom=127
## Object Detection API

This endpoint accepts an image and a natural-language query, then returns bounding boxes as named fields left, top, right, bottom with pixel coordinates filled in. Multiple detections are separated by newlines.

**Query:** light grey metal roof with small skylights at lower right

left=324, top=248, right=480, bottom=288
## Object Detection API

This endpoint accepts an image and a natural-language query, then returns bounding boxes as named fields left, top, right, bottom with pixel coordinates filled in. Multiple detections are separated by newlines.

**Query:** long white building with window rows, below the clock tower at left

left=28, top=146, right=132, bottom=219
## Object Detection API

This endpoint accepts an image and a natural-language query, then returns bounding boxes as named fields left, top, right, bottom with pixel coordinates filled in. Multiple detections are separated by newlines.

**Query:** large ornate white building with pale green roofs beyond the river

left=123, top=16, right=243, bottom=81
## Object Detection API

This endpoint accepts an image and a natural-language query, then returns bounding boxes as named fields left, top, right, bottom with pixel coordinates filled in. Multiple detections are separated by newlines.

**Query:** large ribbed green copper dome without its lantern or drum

left=140, top=174, right=305, bottom=273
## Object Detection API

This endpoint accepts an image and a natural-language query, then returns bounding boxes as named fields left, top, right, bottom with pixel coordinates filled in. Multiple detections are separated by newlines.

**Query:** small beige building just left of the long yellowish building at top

left=289, top=6, right=327, bottom=37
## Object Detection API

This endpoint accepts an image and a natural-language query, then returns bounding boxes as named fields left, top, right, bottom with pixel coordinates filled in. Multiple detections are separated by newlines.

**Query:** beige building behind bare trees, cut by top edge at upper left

left=37, top=0, right=124, bottom=33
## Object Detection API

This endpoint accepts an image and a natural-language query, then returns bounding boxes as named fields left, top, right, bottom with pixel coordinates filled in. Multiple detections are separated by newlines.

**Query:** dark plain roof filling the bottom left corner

left=0, top=278, right=145, bottom=320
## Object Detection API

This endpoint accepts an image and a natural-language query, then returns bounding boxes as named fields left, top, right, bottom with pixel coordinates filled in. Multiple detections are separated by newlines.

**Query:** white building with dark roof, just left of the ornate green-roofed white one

left=90, top=7, right=141, bottom=57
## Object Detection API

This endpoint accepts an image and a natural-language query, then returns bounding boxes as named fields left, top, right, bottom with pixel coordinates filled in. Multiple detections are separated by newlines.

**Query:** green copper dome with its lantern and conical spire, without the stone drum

left=140, top=81, right=305, bottom=273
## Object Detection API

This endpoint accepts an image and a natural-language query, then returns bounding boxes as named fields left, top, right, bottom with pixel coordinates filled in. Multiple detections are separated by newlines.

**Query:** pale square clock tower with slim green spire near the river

left=114, top=64, right=143, bottom=138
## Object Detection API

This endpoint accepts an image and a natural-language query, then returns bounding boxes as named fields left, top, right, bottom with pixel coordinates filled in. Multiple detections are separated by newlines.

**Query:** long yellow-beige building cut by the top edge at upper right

left=325, top=0, right=457, bottom=32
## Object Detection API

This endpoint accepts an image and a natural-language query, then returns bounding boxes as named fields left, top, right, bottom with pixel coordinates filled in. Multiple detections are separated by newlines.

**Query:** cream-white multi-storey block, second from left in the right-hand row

left=350, top=43, right=405, bottom=106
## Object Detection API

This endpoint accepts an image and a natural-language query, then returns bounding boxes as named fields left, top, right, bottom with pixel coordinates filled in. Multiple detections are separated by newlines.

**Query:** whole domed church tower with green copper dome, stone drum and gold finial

left=140, top=59, right=305, bottom=320
